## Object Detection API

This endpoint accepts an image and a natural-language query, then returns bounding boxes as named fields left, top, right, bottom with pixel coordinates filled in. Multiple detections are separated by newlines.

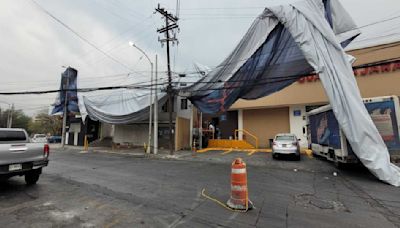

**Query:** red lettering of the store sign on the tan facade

left=298, top=62, right=400, bottom=83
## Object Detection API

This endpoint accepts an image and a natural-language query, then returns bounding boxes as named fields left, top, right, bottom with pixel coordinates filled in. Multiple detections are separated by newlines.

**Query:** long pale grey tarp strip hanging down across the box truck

left=282, top=1, right=400, bottom=186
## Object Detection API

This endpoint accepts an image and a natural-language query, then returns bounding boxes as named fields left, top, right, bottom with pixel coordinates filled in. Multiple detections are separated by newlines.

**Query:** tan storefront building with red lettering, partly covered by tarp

left=230, top=42, right=400, bottom=147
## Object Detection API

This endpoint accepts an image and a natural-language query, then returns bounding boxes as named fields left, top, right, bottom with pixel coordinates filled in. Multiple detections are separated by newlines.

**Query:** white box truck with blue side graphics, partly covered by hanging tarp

left=307, top=96, right=400, bottom=166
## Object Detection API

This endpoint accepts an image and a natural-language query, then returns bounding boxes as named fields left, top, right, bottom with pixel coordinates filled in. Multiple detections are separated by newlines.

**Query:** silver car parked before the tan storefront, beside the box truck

left=272, top=133, right=300, bottom=160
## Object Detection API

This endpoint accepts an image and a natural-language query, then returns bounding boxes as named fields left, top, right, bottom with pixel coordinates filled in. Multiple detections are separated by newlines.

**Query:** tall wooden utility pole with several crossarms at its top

left=156, top=4, right=178, bottom=155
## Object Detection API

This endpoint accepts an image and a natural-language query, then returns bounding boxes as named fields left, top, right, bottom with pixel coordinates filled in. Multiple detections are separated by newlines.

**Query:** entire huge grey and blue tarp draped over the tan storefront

left=189, top=0, right=400, bottom=186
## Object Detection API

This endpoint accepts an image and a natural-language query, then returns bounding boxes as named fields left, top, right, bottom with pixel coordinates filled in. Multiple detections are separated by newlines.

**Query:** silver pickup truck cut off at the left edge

left=0, top=128, right=50, bottom=185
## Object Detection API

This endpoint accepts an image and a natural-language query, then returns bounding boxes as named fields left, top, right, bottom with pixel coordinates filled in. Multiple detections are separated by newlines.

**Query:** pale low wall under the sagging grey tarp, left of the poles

left=113, top=124, right=149, bottom=146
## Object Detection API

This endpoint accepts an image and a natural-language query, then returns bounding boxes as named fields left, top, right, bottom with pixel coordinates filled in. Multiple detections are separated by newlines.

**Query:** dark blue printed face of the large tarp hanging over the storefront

left=189, top=0, right=358, bottom=113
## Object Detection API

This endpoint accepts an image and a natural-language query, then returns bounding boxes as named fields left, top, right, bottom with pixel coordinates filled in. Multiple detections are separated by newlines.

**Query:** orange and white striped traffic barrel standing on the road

left=226, top=158, right=253, bottom=210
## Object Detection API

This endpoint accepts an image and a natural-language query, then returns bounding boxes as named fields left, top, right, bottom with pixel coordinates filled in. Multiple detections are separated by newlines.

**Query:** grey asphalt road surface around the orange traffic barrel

left=0, top=149, right=400, bottom=228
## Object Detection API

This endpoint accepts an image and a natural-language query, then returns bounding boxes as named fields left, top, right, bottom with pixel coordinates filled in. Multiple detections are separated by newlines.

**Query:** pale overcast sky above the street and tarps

left=0, top=0, right=400, bottom=116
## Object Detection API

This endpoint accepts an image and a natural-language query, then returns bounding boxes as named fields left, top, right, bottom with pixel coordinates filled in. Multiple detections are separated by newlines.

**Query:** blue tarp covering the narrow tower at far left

left=51, top=67, right=79, bottom=115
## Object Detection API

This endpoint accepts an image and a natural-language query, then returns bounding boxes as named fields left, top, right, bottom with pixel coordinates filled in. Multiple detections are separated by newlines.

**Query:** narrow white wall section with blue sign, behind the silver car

left=289, top=106, right=308, bottom=147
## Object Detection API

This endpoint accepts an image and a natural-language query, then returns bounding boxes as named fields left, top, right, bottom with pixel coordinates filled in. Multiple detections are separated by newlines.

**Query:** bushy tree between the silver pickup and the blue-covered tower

left=29, top=110, right=62, bottom=135
